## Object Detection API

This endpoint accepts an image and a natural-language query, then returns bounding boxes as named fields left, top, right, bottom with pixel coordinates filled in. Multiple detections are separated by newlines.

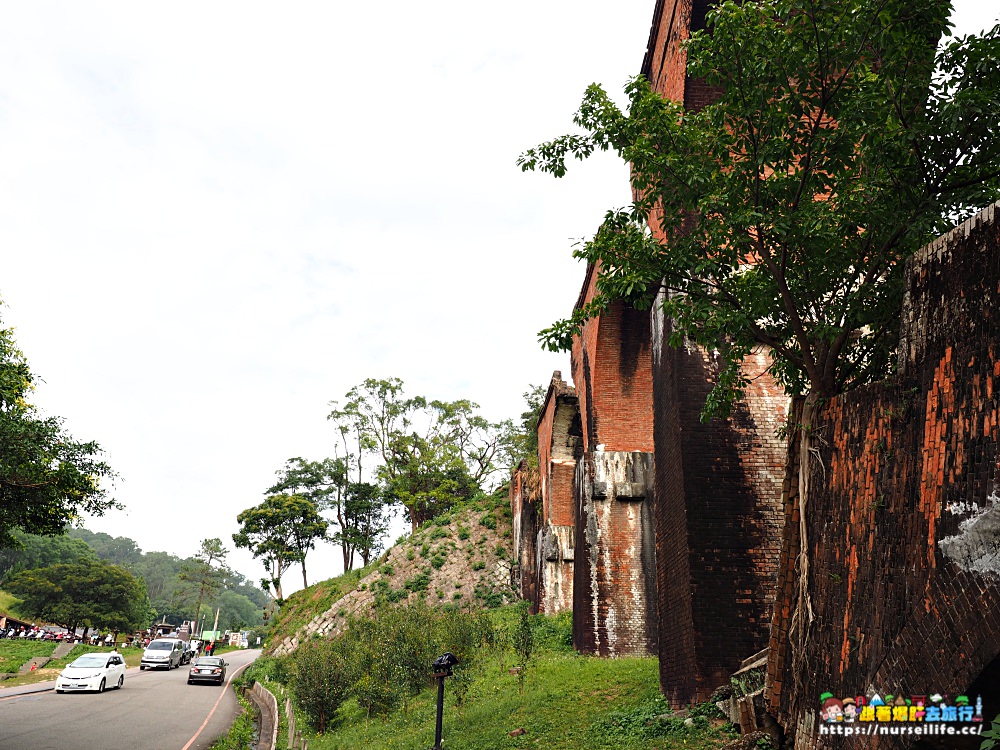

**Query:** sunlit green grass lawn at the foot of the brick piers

left=309, top=653, right=733, bottom=750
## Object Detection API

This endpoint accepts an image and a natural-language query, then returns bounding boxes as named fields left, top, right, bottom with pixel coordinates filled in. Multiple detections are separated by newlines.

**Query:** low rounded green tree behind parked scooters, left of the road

left=5, top=560, right=152, bottom=631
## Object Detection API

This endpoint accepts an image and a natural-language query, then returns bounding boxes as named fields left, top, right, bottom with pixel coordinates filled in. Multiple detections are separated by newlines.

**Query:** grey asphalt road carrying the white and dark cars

left=0, top=650, right=260, bottom=750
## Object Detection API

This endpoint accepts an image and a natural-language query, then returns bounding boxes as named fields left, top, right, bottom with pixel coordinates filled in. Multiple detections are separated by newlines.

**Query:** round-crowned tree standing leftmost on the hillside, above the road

left=233, top=495, right=329, bottom=602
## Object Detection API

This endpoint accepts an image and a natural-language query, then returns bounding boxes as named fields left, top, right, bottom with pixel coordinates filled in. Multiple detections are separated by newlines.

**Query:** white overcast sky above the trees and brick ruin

left=0, top=0, right=997, bottom=591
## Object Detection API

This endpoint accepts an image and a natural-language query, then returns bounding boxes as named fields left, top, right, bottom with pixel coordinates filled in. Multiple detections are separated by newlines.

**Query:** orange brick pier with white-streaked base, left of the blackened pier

left=572, top=266, right=656, bottom=655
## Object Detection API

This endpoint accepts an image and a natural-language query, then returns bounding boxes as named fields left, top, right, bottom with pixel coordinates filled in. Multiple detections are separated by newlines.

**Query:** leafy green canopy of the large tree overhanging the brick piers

left=519, top=0, right=1000, bottom=413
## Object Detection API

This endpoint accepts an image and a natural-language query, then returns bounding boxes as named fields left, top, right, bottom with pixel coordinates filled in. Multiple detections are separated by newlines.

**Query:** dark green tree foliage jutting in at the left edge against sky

left=0, top=314, right=118, bottom=547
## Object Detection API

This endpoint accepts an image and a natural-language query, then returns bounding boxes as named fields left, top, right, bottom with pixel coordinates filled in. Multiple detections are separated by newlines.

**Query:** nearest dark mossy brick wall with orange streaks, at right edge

left=768, top=207, right=1000, bottom=748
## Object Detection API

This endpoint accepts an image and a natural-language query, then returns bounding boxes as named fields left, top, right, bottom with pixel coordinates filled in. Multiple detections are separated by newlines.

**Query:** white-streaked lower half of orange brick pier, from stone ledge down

left=573, top=451, right=657, bottom=656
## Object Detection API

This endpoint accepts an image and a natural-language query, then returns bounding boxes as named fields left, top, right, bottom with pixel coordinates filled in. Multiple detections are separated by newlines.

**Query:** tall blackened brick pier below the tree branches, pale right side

left=654, top=296, right=788, bottom=705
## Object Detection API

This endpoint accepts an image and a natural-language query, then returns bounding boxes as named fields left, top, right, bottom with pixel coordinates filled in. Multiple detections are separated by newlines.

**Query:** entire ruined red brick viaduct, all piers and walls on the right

left=511, top=0, right=1000, bottom=748
